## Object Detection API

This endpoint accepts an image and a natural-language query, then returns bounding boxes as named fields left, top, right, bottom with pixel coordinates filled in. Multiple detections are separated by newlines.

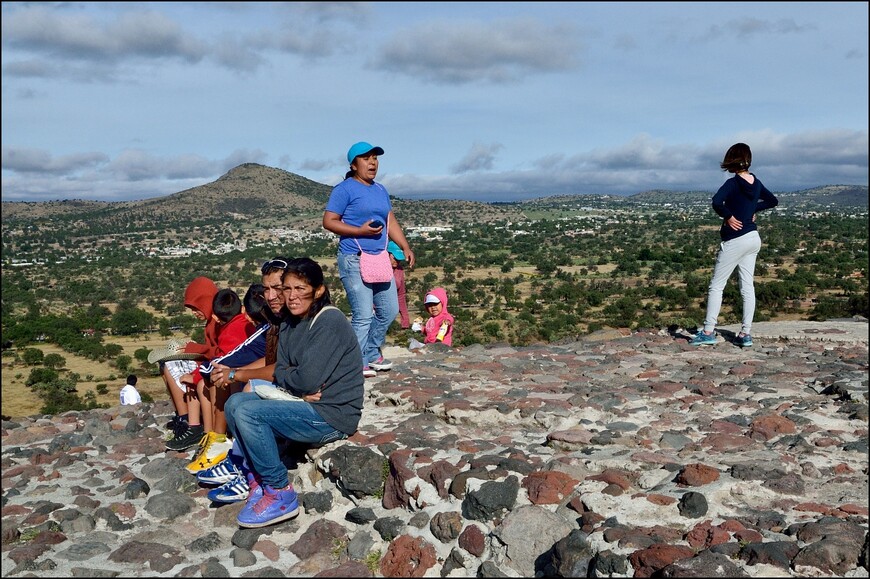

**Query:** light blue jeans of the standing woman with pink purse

left=337, top=253, right=399, bottom=366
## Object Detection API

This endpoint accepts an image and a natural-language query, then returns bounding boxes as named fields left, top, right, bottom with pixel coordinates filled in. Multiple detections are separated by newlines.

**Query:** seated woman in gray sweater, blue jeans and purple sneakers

left=225, top=257, right=365, bottom=527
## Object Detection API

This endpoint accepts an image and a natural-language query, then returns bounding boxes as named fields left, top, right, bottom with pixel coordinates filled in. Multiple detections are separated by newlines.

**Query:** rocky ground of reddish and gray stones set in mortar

left=2, top=320, right=868, bottom=577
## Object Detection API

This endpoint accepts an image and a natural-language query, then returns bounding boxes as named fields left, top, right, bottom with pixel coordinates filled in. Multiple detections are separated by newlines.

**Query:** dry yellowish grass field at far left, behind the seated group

left=2, top=334, right=184, bottom=418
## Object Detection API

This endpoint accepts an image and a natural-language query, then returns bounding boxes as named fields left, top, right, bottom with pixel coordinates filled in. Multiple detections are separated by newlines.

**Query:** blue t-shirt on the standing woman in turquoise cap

left=326, top=177, right=393, bottom=254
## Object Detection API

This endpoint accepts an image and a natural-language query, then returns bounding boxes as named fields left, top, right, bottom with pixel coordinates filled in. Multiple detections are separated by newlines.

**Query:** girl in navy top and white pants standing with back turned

left=689, top=143, right=779, bottom=348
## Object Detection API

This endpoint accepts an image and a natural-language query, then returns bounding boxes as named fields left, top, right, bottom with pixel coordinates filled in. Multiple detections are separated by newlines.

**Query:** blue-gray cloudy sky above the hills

left=0, top=2, right=868, bottom=201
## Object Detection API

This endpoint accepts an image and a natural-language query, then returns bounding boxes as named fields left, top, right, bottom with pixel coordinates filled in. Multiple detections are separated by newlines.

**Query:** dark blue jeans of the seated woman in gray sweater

left=224, top=392, right=347, bottom=489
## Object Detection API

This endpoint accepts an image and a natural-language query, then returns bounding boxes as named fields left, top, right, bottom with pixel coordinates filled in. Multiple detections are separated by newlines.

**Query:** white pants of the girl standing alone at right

left=704, top=231, right=761, bottom=334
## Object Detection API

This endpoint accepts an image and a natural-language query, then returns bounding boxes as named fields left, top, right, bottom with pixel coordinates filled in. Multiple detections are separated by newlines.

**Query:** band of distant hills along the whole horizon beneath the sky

left=2, top=163, right=868, bottom=231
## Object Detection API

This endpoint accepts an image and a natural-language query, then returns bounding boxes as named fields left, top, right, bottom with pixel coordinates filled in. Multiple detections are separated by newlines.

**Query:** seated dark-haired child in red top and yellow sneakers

left=182, top=288, right=254, bottom=474
